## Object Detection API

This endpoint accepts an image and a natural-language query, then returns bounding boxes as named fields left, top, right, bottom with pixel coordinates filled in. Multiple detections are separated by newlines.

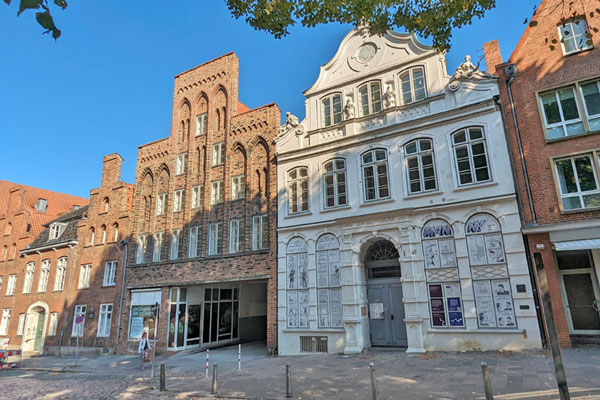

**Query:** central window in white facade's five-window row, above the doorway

left=361, top=149, right=390, bottom=201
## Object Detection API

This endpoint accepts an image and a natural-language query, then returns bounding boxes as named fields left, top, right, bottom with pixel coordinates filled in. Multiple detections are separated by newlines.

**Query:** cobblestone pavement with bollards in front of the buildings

left=0, top=344, right=600, bottom=400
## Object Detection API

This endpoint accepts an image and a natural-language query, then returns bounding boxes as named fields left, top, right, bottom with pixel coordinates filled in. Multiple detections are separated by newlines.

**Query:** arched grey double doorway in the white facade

left=365, top=240, right=408, bottom=346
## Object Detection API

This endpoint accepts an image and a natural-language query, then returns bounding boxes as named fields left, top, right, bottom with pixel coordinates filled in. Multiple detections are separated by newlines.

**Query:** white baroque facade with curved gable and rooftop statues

left=276, top=28, right=541, bottom=354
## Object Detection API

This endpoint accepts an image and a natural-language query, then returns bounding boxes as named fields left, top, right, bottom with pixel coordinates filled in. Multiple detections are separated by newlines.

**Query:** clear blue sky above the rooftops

left=0, top=0, right=538, bottom=197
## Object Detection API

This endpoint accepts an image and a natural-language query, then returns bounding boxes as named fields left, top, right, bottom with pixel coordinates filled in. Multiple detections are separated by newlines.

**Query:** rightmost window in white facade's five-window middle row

left=452, top=127, right=491, bottom=185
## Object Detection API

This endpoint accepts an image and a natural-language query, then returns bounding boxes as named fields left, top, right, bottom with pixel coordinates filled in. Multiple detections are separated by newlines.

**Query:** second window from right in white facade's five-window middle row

left=404, top=139, right=437, bottom=194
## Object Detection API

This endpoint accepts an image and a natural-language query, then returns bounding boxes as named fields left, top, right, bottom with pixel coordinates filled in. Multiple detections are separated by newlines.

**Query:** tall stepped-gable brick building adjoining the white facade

left=121, top=53, right=280, bottom=351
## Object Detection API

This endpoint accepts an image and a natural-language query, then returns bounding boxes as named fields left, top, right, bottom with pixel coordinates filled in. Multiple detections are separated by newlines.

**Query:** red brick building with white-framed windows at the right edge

left=484, top=0, right=600, bottom=347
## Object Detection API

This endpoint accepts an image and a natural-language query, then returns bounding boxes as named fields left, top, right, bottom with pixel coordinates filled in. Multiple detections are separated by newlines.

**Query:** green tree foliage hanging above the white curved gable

left=226, top=0, right=496, bottom=50
